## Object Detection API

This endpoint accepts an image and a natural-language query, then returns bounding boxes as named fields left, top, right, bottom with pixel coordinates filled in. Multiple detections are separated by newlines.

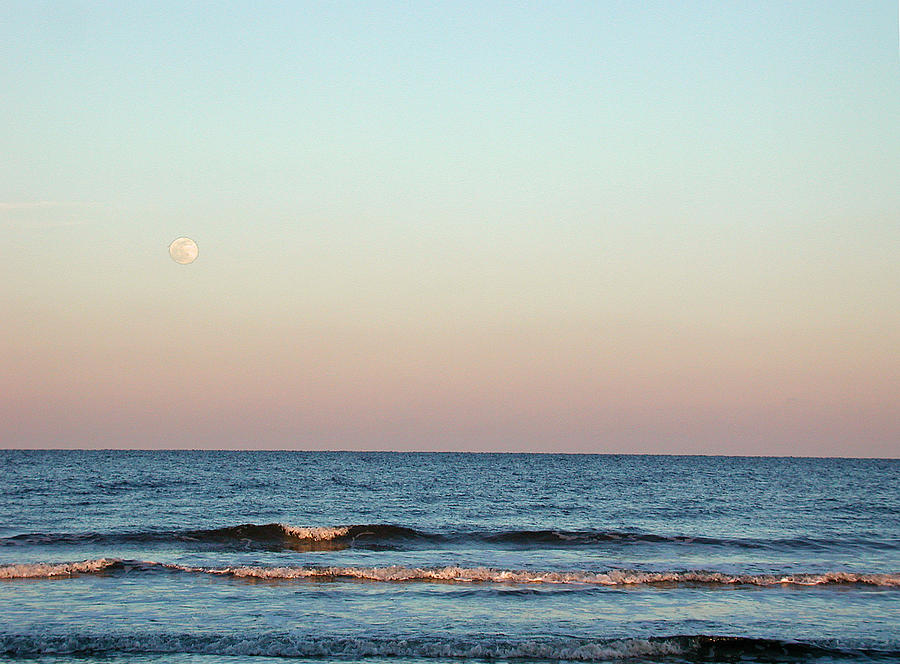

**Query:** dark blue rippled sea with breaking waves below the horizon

left=0, top=451, right=900, bottom=663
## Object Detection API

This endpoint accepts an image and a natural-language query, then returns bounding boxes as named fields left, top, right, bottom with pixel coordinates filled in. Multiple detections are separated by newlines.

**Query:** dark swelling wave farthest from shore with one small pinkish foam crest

left=0, top=523, right=900, bottom=551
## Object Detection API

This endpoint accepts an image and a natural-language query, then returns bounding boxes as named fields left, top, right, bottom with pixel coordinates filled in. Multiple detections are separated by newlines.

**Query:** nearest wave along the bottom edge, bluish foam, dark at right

left=0, top=632, right=900, bottom=662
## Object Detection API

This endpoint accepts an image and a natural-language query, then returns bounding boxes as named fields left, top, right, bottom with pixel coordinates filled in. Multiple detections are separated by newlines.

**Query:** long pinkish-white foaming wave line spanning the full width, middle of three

left=0, top=558, right=900, bottom=588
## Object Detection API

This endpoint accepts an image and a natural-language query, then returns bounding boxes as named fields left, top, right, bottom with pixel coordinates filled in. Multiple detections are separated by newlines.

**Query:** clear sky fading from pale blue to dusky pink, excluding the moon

left=0, top=0, right=900, bottom=457
